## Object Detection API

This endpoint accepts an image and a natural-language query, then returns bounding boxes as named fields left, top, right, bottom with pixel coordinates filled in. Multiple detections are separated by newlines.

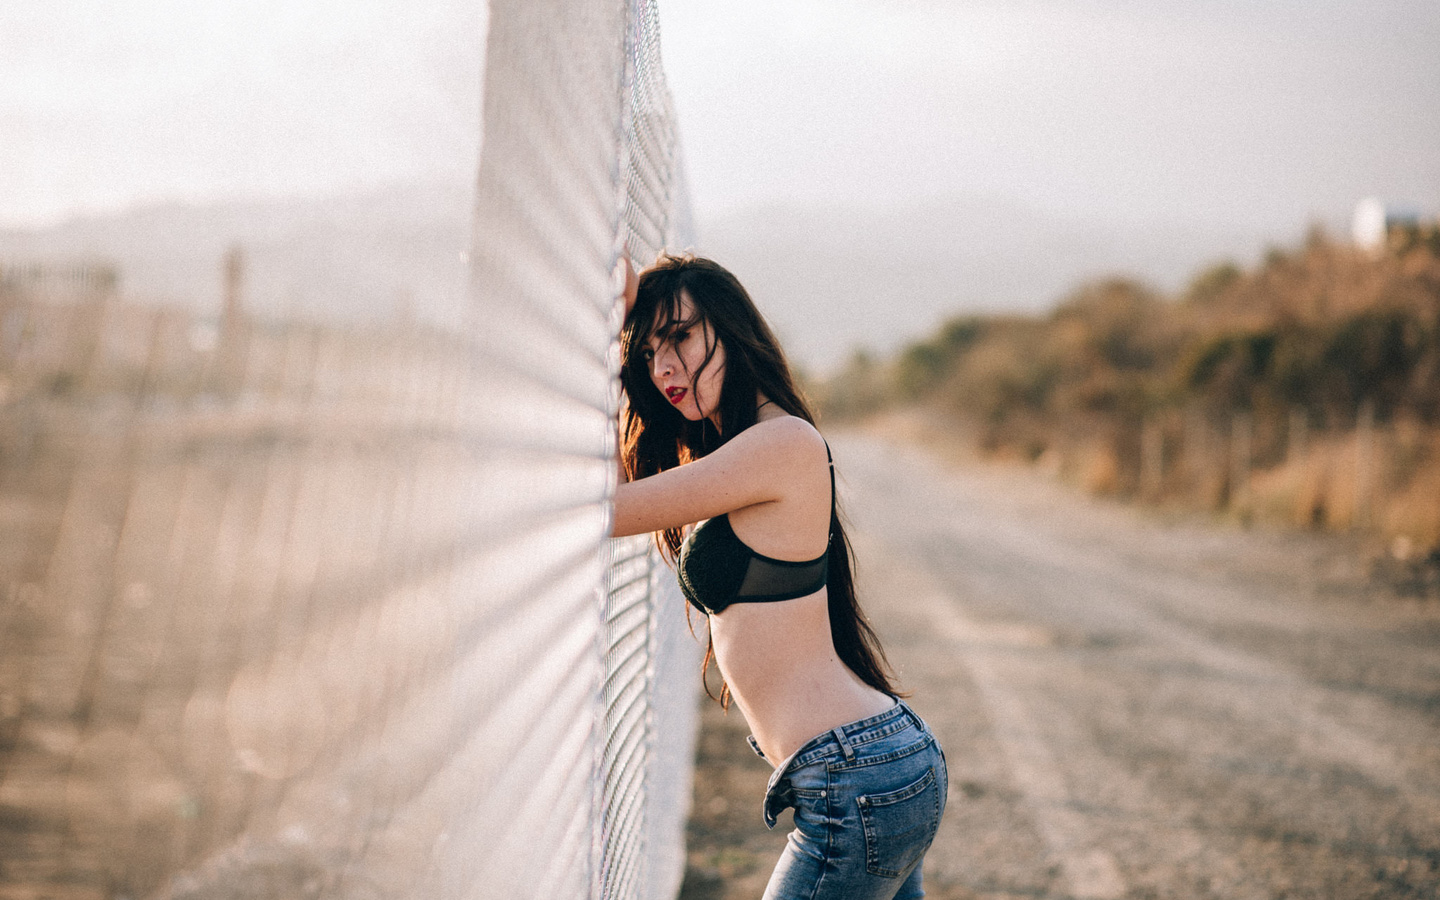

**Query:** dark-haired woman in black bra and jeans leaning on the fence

left=615, top=255, right=948, bottom=900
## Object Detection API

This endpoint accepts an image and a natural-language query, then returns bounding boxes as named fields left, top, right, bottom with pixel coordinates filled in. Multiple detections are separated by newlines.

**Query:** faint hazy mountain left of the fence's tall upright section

left=0, top=184, right=471, bottom=326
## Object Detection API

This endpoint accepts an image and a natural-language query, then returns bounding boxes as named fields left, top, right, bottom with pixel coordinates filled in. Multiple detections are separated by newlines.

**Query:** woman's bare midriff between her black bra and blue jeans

left=710, top=588, right=894, bottom=766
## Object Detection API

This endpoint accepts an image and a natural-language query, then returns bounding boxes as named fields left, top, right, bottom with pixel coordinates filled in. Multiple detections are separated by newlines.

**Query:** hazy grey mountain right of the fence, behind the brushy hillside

left=700, top=197, right=1260, bottom=372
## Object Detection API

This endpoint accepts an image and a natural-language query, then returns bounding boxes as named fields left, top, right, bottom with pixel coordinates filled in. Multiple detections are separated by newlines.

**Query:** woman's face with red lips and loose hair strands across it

left=642, top=291, right=724, bottom=422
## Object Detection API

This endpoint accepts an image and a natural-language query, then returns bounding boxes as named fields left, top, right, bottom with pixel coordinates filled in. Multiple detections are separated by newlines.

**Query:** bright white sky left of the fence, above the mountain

left=0, top=0, right=485, bottom=226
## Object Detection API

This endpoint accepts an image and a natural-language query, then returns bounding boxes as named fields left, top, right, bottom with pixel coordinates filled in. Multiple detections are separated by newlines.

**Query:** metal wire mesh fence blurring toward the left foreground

left=0, top=0, right=698, bottom=900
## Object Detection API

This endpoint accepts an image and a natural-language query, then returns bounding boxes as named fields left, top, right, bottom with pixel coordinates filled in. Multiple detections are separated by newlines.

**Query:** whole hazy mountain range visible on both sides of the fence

left=0, top=184, right=1260, bottom=372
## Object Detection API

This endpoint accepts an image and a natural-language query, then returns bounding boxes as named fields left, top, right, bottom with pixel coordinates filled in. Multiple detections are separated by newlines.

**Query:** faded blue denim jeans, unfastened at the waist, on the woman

left=750, top=701, right=949, bottom=900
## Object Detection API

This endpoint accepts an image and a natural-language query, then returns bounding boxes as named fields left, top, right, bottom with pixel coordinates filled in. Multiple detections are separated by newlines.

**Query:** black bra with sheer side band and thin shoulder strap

left=677, top=444, right=835, bottom=615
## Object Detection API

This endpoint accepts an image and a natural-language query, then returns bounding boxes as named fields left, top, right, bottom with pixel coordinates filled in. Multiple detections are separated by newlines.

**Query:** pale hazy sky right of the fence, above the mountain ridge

left=661, top=0, right=1440, bottom=229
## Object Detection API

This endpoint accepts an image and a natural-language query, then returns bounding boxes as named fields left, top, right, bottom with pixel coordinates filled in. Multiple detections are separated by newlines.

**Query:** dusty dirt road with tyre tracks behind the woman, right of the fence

left=683, top=436, right=1440, bottom=900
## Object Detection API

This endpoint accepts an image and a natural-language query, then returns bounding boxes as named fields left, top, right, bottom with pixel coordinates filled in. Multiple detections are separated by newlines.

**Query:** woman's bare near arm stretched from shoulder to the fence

left=611, top=416, right=825, bottom=537
